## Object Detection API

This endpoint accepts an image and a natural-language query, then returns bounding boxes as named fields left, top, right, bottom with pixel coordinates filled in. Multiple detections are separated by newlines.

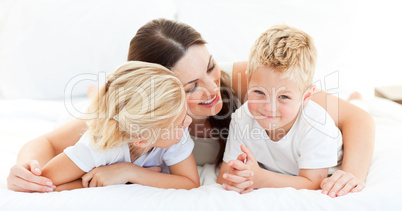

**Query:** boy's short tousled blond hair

left=247, top=25, right=317, bottom=92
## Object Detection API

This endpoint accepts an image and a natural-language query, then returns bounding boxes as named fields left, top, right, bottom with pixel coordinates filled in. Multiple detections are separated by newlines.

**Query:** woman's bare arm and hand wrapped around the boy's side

left=312, top=91, right=375, bottom=197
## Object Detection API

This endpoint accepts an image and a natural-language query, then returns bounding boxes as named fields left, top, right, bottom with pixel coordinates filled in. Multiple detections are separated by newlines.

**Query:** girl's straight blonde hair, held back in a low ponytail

left=87, top=61, right=185, bottom=156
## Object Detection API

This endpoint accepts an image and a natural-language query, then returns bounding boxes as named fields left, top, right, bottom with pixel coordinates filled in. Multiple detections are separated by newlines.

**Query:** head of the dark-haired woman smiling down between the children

left=128, top=19, right=222, bottom=119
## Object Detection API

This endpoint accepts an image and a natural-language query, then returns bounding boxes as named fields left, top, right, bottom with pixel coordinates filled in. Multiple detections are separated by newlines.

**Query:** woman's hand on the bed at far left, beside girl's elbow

left=7, top=160, right=56, bottom=192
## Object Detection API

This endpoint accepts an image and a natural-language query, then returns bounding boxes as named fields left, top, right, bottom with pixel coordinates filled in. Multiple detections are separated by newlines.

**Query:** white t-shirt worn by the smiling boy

left=223, top=101, right=342, bottom=176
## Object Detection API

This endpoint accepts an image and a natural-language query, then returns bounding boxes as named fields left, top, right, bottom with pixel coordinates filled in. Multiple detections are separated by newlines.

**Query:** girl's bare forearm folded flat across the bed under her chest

left=82, top=154, right=200, bottom=189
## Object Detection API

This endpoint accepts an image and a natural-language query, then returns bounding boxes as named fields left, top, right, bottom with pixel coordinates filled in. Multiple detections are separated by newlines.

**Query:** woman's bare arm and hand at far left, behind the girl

left=7, top=119, right=87, bottom=192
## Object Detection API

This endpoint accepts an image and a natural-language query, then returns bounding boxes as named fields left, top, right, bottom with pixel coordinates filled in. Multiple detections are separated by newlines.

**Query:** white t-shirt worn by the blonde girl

left=64, top=129, right=194, bottom=173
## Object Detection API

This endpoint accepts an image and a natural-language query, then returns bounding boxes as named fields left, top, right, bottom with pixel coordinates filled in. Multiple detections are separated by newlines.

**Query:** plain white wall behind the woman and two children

left=0, top=0, right=402, bottom=98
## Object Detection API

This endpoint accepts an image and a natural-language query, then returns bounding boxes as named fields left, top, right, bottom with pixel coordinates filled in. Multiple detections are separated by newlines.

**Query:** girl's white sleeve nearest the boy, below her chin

left=162, top=128, right=194, bottom=166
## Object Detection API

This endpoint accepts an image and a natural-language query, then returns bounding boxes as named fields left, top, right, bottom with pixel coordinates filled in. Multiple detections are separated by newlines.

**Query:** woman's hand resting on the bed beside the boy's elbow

left=321, top=170, right=365, bottom=198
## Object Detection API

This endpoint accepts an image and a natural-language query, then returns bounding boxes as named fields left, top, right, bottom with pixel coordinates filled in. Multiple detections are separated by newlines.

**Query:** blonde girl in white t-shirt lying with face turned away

left=43, top=62, right=200, bottom=190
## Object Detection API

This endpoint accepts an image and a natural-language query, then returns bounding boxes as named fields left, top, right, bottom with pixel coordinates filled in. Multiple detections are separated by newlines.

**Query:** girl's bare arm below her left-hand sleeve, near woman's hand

left=42, top=152, right=85, bottom=190
